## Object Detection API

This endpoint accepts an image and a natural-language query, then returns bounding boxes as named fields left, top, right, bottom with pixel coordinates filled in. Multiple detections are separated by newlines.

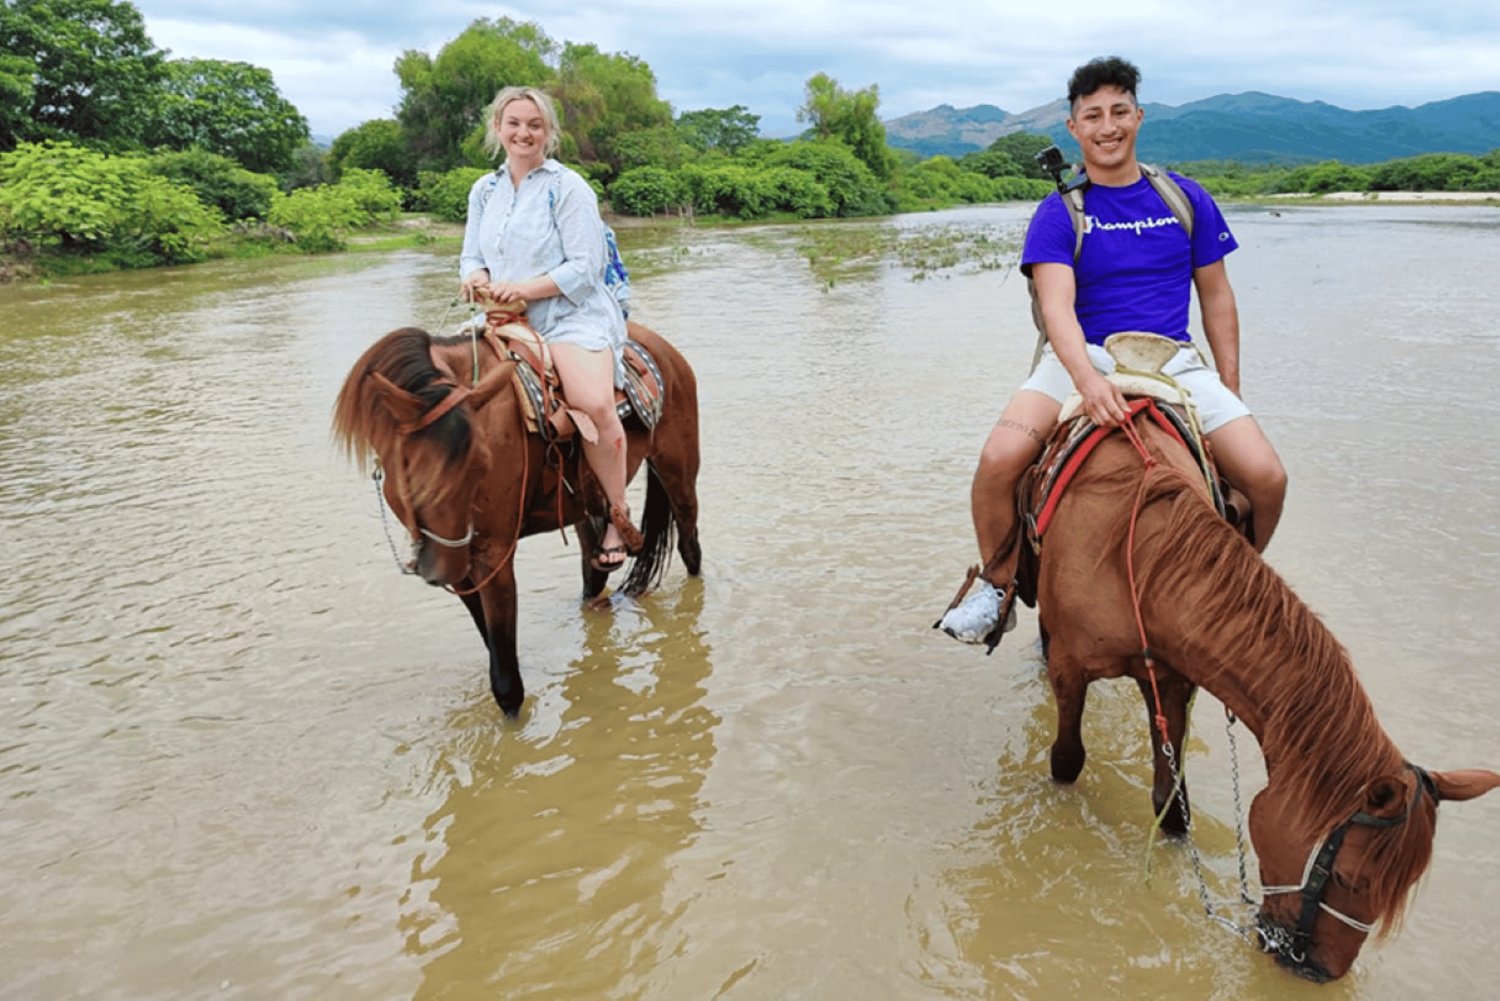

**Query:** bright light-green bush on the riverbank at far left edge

left=0, top=141, right=224, bottom=264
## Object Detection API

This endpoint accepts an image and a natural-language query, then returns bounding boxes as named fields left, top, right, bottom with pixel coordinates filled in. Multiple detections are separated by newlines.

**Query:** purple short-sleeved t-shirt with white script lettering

left=1022, top=174, right=1239, bottom=344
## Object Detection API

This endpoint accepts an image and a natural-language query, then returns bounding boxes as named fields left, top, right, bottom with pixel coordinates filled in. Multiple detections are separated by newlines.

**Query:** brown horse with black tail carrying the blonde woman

left=333, top=323, right=702, bottom=716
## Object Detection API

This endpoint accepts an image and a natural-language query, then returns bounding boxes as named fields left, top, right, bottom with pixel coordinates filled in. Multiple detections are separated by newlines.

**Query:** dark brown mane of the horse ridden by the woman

left=333, top=327, right=479, bottom=504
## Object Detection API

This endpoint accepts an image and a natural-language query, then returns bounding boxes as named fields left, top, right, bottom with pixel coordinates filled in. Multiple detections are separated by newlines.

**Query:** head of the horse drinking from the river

left=1250, top=764, right=1500, bottom=983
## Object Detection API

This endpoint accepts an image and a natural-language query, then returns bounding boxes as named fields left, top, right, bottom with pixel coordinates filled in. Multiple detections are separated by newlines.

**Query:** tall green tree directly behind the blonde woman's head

left=396, top=18, right=557, bottom=171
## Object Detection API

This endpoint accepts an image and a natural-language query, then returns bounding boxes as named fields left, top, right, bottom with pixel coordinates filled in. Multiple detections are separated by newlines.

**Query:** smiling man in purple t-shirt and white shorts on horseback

left=941, top=57, right=1287, bottom=642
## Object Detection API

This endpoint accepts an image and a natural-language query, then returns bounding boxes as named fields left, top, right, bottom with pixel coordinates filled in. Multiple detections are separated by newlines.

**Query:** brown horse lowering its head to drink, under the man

left=1008, top=405, right=1500, bottom=980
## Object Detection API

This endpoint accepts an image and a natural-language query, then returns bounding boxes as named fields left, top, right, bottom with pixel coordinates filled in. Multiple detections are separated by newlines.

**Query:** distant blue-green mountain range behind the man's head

left=885, top=90, right=1500, bottom=164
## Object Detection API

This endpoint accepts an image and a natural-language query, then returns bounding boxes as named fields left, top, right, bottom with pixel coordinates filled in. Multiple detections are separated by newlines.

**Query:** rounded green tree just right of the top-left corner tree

left=143, top=59, right=309, bottom=174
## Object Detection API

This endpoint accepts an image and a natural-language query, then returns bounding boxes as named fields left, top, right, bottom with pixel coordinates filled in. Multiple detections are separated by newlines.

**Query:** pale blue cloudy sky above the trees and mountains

left=134, top=0, right=1500, bottom=138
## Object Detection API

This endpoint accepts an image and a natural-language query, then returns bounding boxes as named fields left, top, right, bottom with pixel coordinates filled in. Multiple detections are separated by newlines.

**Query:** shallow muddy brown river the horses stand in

left=0, top=199, right=1500, bottom=1001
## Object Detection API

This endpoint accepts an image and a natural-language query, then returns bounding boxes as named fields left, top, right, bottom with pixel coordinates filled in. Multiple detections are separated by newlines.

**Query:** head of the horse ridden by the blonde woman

left=333, top=327, right=500, bottom=585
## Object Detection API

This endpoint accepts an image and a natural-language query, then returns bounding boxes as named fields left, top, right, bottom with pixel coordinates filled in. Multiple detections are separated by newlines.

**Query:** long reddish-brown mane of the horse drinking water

left=1122, top=459, right=1437, bottom=936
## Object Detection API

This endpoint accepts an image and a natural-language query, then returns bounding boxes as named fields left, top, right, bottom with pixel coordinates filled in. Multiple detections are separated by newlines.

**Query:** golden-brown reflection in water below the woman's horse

left=401, top=581, right=719, bottom=998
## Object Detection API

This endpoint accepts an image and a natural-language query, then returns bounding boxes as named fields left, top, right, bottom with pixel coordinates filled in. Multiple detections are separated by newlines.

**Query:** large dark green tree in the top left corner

left=0, top=0, right=164, bottom=149
